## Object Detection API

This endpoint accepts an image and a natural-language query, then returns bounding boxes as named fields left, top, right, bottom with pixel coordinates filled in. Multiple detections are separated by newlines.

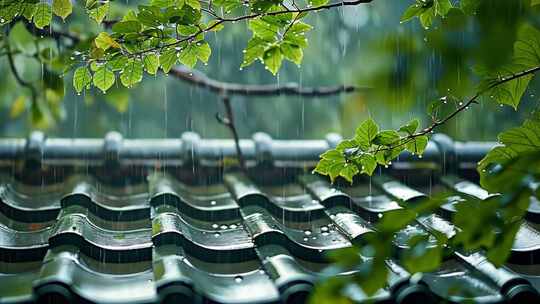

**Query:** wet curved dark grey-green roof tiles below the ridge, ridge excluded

left=0, top=164, right=540, bottom=303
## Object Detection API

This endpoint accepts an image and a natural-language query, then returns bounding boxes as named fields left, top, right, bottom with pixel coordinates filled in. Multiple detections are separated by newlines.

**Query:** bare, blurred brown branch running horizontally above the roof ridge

left=169, top=66, right=369, bottom=97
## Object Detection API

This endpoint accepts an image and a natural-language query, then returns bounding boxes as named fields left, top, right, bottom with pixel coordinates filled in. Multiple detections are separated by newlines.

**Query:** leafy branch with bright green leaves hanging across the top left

left=0, top=0, right=372, bottom=93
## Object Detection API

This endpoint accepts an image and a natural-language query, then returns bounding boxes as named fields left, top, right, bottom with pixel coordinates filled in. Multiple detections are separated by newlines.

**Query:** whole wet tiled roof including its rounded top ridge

left=0, top=133, right=540, bottom=303
